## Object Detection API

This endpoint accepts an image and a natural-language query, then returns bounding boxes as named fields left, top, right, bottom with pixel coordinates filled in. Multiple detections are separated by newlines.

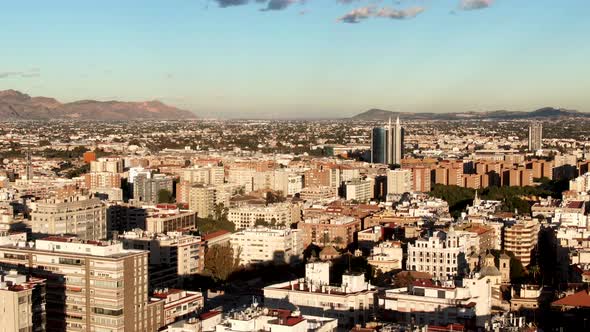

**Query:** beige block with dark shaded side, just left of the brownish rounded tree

left=119, top=229, right=205, bottom=288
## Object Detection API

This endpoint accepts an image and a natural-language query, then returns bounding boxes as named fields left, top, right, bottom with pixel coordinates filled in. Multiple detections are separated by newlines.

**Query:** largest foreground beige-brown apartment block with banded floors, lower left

left=0, top=236, right=164, bottom=332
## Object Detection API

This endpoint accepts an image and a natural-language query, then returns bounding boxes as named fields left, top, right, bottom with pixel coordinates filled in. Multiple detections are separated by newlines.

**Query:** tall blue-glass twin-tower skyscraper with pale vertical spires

left=371, top=117, right=404, bottom=164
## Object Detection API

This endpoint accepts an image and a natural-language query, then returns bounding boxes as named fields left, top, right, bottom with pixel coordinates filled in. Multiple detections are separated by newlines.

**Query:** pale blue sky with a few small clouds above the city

left=0, top=0, right=590, bottom=118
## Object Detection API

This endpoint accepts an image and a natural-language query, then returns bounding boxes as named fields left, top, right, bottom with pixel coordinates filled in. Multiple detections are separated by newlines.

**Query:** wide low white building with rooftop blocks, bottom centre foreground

left=264, top=262, right=377, bottom=328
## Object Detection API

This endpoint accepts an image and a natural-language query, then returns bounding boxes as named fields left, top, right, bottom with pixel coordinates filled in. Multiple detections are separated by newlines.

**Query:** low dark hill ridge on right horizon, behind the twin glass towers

left=350, top=107, right=590, bottom=121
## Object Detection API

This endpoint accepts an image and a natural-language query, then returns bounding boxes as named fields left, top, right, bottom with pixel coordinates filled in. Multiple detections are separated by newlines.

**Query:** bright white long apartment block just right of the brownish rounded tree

left=230, top=227, right=304, bottom=265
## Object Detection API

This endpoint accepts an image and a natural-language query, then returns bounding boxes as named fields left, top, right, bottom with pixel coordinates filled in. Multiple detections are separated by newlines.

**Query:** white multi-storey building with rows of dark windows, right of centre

left=406, top=230, right=477, bottom=280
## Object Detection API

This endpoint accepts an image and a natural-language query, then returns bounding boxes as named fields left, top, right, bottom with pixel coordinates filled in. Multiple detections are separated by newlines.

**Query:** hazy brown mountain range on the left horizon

left=0, top=90, right=196, bottom=121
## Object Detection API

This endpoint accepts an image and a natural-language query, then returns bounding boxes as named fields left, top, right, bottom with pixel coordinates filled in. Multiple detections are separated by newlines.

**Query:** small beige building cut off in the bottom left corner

left=0, top=270, right=46, bottom=332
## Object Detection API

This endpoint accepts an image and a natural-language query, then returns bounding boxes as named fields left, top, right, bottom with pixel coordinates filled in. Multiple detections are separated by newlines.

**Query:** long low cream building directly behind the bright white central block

left=227, top=203, right=301, bottom=230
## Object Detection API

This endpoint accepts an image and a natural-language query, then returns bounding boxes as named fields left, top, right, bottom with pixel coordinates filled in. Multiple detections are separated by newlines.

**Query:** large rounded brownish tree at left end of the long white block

left=204, top=245, right=240, bottom=282
